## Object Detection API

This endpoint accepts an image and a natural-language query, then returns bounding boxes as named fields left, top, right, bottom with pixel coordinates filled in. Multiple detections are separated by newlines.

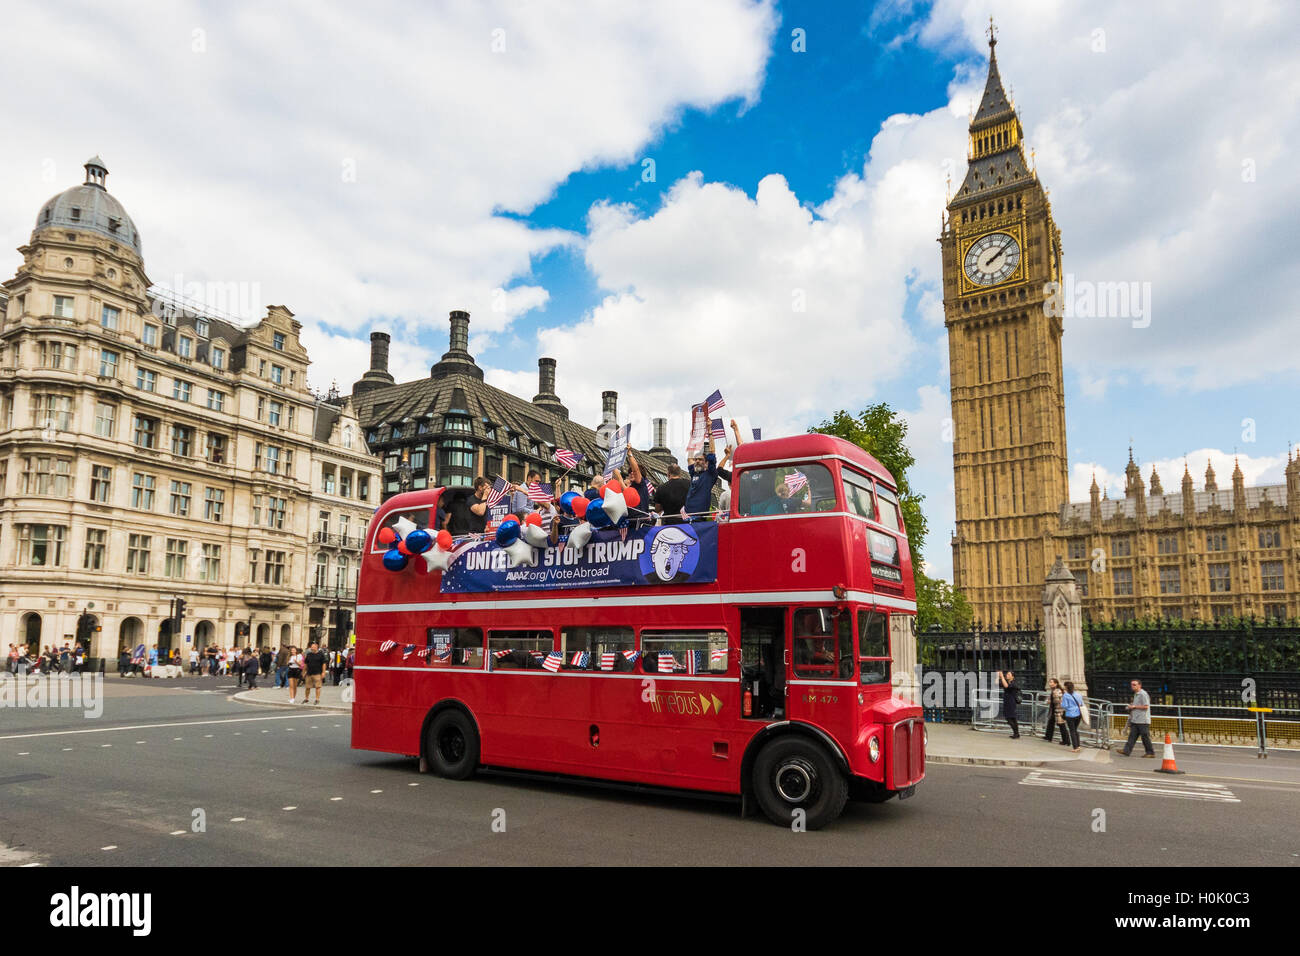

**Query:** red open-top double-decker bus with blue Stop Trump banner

left=352, top=434, right=924, bottom=829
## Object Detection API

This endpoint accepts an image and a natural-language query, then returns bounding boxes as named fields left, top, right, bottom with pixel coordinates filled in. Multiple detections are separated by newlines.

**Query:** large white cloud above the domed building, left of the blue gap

left=0, top=0, right=776, bottom=340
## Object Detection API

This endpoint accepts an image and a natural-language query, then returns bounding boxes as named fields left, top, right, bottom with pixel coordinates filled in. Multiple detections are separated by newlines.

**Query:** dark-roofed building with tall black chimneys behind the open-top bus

left=352, top=311, right=671, bottom=501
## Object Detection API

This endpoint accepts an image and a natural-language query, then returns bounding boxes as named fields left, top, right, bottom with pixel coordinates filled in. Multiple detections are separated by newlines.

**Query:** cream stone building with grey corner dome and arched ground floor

left=0, top=157, right=378, bottom=658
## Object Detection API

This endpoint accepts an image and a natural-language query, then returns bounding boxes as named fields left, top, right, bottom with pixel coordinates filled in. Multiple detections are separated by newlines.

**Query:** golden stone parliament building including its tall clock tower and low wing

left=939, top=30, right=1300, bottom=627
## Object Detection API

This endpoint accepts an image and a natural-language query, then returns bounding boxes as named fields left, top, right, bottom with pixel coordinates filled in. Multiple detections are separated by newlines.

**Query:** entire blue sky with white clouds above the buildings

left=0, top=0, right=1300, bottom=578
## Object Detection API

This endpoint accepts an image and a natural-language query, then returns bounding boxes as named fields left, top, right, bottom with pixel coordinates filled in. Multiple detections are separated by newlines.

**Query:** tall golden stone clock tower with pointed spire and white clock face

left=939, top=23, right=1069, bottom=627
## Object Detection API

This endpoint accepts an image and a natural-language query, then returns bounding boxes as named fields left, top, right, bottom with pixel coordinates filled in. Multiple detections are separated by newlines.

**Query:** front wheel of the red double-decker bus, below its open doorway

left=754, top=736, right=849, bottom=830
